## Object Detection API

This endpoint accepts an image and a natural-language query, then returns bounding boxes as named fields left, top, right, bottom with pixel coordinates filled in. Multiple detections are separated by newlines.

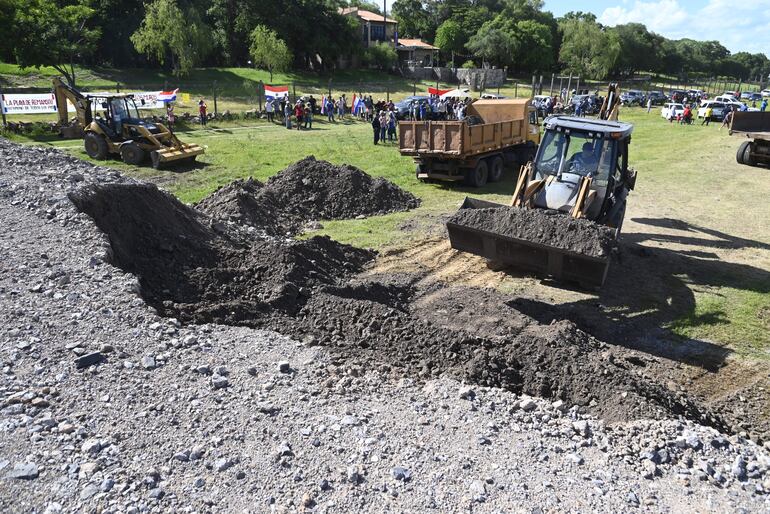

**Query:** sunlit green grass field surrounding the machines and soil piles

left=6, top=98, right=770, bottom=358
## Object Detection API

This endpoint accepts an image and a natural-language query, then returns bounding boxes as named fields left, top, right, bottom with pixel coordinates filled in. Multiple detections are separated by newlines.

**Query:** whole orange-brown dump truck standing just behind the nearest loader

left=398, top=99, right=540, bottom=187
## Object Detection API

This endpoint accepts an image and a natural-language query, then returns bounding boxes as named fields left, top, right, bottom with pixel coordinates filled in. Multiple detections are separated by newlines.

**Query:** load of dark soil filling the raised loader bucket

left=447, top=207, right=615, bottom=258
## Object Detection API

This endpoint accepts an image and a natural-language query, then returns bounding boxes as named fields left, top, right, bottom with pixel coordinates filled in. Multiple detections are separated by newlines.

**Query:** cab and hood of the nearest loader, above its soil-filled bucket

left=525, top=116, right=635, bottom=227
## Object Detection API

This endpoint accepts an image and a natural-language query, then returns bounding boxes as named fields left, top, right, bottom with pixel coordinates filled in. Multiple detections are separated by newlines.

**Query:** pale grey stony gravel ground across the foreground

left=0, top=140, right=770, bottom=513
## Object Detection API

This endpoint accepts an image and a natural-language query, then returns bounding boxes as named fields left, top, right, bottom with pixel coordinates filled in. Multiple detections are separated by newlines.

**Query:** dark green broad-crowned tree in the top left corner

left=9, top=0, right=99, bottom=87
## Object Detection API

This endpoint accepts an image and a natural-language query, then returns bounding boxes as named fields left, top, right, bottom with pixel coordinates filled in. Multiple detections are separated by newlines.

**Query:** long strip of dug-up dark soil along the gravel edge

left=70, top=178, right=727, bottom=430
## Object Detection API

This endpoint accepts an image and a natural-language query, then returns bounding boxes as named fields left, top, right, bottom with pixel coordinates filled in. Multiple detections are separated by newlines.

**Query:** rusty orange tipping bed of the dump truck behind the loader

left=398, top=100, right=529, bottom=159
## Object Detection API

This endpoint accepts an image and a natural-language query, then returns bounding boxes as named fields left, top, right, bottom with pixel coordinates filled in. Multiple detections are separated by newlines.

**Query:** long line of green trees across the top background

left=0, top=0, right=770, bottom=87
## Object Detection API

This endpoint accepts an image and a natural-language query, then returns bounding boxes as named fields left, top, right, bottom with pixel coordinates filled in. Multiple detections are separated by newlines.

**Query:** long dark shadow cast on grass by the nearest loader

left=500, top=218, right=770, bottom=371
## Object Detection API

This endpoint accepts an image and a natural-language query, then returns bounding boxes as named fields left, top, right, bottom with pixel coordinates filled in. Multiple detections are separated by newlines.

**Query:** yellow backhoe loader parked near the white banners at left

left=53, top=77, right=204, bottom=168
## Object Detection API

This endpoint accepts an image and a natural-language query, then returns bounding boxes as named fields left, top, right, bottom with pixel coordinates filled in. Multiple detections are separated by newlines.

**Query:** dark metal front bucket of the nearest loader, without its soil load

left=446, top=197, right=610, bottom=289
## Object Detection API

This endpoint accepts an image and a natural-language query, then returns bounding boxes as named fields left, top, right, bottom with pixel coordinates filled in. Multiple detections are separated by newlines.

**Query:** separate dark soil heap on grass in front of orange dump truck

left=196, top=156, right=420, bottom=235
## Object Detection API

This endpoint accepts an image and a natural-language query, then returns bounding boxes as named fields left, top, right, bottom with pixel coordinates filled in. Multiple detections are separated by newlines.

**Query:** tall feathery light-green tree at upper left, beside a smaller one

left=131, top=0, right=211, bottom=75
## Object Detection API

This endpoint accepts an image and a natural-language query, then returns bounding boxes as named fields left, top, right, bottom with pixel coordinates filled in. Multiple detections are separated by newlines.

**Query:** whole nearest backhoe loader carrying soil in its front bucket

left=446, top=84, right=636, bottom=289
